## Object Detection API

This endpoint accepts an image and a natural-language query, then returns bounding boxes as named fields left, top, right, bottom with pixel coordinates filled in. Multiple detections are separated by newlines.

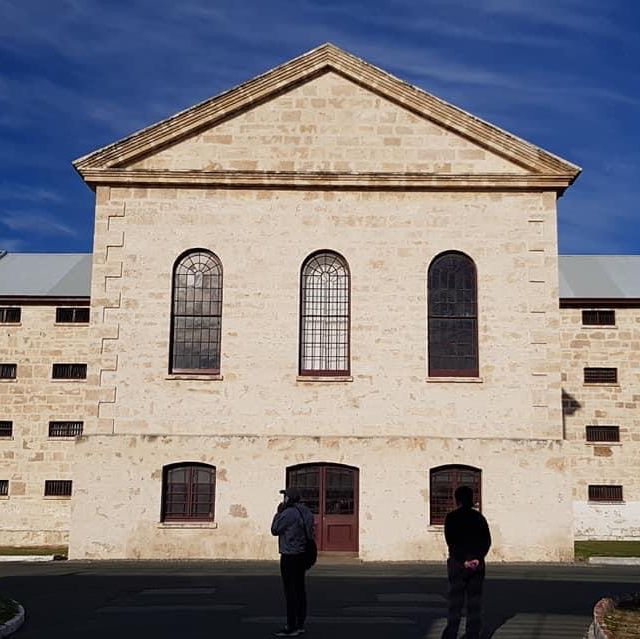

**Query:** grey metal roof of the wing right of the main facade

left=559, top=255, right=640, bottom=299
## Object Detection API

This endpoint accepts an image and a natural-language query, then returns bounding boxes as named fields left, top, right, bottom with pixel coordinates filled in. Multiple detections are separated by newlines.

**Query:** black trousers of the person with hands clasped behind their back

left=442, top=559, right=484, bottom=639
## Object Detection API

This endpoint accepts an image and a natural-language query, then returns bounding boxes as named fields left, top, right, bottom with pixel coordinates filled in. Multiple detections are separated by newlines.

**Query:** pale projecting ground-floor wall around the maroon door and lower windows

left=71, top=435, right=573, bottom=561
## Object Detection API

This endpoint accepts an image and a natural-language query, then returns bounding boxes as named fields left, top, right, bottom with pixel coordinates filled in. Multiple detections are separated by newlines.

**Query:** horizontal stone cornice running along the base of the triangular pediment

left=83, top=169, right=573, bottom=192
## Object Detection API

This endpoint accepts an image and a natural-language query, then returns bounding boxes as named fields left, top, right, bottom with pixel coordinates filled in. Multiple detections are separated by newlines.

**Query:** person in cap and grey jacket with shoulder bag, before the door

left=271, top=487, right=315, bottom=637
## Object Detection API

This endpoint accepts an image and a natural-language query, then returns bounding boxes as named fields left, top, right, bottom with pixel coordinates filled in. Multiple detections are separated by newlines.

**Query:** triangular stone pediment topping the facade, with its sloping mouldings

left=74, top=44, right=580, bottom=185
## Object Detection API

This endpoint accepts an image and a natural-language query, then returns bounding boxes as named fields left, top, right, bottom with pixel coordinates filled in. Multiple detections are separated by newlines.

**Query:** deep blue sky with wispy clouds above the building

left=0, top=0, right=640, bottom=253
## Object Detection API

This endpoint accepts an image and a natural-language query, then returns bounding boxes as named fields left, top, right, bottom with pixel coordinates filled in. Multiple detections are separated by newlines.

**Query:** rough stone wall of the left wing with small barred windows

left=0, top=305, right=89, bottom=545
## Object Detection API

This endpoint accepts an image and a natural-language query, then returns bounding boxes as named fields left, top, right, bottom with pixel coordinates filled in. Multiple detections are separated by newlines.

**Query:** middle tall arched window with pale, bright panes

left=300, top=251, right=350, bottom=376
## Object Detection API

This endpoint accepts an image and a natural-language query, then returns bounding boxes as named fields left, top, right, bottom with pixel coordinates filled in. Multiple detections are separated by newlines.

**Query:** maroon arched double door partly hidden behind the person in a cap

left=287, top=464, right=358, bottom=552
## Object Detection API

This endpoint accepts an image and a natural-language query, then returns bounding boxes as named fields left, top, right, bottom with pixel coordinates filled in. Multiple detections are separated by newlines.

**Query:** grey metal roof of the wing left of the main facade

left=0, top=253, right=92, bottom=297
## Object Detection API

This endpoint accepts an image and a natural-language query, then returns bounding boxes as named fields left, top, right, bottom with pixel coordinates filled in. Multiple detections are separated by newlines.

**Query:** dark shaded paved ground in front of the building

left=0, top=560, right=638, bottom=639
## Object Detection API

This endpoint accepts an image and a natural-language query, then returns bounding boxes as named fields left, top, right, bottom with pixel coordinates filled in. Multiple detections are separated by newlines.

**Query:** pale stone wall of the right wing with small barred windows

left=561, top=308, right=640, bottom=539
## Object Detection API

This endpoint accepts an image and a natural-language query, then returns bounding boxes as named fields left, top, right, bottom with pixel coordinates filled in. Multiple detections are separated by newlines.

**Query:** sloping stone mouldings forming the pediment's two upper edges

left=73, top=43, right=581, bottom=186
